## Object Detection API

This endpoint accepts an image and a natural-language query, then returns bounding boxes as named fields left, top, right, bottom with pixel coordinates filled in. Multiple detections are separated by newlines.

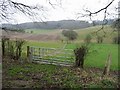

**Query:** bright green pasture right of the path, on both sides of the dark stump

left=66, top=43, right=118, bottom=70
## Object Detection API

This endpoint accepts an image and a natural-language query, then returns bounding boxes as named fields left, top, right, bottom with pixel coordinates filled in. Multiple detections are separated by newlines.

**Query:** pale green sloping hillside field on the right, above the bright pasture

left=75, top=25, right=118, bottom=43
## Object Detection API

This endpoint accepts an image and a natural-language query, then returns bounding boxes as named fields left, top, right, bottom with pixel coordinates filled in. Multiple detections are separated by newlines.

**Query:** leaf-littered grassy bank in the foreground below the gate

left=2, top=59, right=118, bottom=89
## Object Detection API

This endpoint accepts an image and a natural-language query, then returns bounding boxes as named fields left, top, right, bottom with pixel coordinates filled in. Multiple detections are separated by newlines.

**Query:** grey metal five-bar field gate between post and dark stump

left=27, top=46, right=75, bottom=65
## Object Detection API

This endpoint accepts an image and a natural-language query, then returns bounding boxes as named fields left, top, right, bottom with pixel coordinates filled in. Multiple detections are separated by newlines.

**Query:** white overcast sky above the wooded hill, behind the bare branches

left=3, top=0, right=118, bottom=23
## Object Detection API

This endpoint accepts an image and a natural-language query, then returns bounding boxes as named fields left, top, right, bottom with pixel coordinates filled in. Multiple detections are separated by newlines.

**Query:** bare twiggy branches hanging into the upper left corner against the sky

left=0, top=0, right=46, bottom=22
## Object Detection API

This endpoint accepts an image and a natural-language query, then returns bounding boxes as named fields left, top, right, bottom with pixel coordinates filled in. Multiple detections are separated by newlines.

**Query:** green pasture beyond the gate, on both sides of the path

left=22, top=41, right=118, bottom=70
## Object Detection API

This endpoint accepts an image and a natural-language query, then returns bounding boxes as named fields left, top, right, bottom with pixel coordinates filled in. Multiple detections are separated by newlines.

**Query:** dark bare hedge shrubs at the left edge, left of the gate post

left=2, top=37, right=25, bottom=60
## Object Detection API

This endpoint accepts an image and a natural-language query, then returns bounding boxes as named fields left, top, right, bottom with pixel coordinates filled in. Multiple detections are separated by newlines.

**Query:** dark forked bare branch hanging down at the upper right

left=77, top=0, right=117, bottom=36
